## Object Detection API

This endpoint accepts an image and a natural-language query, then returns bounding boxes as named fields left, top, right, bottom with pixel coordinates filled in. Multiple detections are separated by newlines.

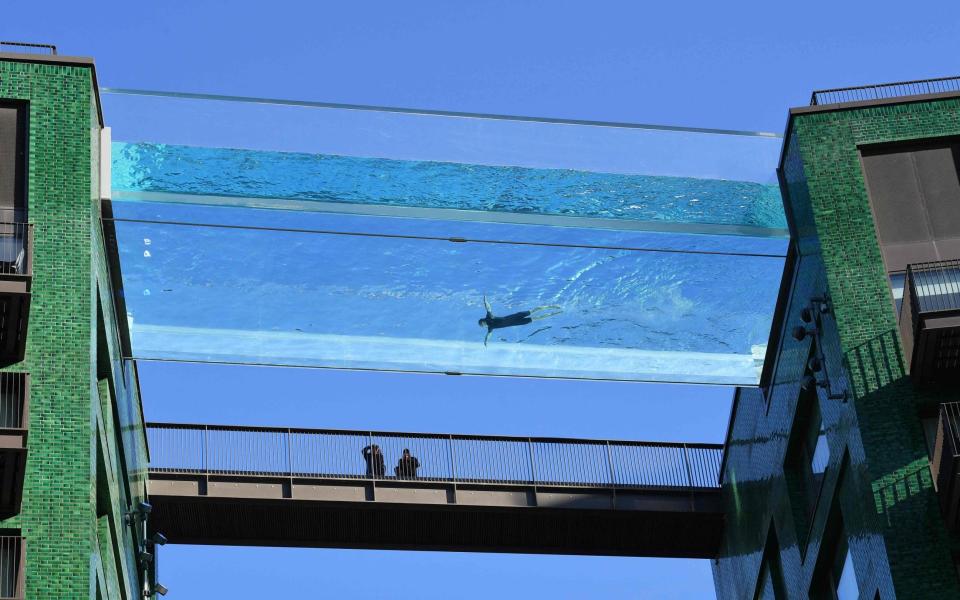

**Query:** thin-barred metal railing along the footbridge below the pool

left=147, top=423, right=723, bottom=488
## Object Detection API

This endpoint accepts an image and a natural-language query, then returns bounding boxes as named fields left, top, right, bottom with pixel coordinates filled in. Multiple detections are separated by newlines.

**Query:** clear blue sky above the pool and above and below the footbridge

left=7, top=0, right=960, bottom=599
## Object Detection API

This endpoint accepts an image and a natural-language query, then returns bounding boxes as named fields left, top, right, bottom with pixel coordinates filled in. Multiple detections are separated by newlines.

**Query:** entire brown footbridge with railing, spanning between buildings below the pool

left=147, top=423, right=723, bottom=558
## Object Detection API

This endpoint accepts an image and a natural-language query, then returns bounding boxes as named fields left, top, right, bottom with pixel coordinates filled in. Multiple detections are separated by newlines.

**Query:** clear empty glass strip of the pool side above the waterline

left=102, top=90, right=781, bottom=184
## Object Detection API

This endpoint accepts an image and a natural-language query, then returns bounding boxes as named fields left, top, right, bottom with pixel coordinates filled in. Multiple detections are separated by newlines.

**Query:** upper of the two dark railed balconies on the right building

left=900, top=260, right=960, bottom=383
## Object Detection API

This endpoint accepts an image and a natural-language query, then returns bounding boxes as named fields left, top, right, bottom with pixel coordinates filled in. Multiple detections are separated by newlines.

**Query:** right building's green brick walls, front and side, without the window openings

left=713, top=99, right=960, bottom=600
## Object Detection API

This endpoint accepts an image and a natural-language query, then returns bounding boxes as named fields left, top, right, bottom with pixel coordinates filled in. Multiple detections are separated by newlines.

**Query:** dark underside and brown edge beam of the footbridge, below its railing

left=150, top=472, right=723, bottom=558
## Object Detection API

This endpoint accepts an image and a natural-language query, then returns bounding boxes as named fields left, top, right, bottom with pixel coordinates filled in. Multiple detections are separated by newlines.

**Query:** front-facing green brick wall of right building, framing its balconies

left=793, top=99, right=960, bottom=598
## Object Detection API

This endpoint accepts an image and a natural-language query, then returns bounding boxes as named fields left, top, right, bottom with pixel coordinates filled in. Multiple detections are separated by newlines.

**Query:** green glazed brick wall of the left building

left=0, top=60, right=146, bottom=599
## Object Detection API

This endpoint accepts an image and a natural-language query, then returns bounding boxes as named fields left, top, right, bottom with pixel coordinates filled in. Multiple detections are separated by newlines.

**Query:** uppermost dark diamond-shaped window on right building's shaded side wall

left=783, top=350, right=830, bottom=549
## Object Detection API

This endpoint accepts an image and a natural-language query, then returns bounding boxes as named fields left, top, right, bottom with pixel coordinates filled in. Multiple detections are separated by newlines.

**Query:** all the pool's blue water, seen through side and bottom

left=113, top=144, right=783, bottom=385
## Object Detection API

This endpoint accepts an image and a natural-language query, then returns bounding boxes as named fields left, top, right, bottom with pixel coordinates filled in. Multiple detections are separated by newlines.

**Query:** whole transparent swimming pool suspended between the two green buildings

left=107, top=91, right=787, bottom=385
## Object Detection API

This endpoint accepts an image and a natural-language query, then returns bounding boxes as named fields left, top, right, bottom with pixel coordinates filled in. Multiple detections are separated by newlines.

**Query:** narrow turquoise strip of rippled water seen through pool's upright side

left=113, top=142, right=786, bottom=229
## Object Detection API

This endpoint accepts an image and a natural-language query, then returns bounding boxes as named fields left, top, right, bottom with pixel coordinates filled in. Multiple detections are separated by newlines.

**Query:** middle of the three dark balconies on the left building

left=0, top=373, right=30, bottom=516
